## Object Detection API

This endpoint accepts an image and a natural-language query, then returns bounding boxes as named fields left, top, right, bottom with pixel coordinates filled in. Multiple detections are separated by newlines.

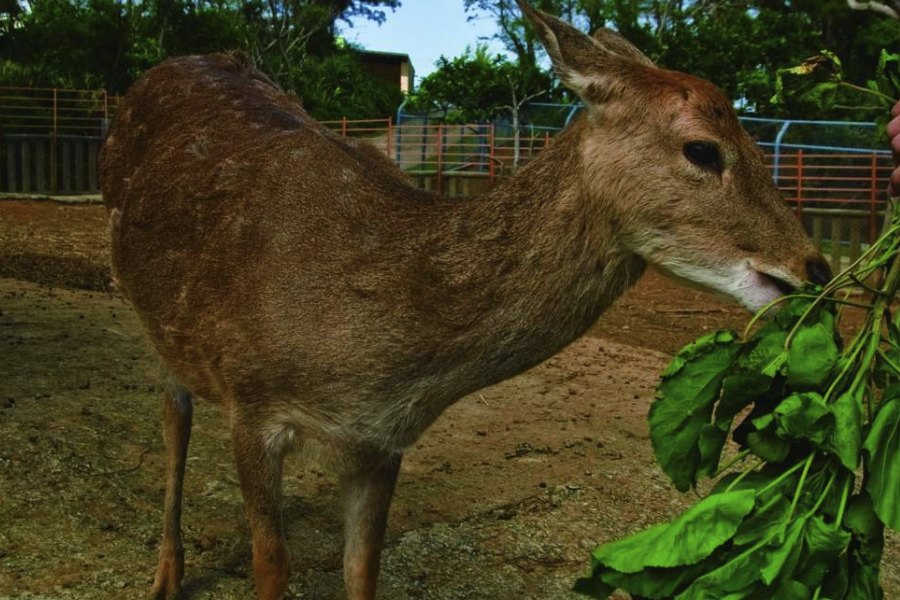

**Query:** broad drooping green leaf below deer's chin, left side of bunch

left=650, top=332, right=741, bottom=491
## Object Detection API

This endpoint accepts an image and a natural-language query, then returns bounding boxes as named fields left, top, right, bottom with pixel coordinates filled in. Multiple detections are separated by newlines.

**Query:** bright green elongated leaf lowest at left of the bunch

left=593, top=490, right=756, bottom=573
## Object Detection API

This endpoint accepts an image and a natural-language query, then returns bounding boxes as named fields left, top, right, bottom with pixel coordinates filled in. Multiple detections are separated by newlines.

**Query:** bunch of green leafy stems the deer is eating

left=575, top=53, right=900, bottom=600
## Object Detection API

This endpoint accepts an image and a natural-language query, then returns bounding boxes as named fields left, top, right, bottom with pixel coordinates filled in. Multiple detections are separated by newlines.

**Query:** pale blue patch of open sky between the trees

left=341, top=0, right=503, bottom=81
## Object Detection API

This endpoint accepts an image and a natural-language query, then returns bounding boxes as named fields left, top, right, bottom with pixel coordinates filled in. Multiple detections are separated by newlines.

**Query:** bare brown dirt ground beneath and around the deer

left=0, top=200, right=900, bottom=600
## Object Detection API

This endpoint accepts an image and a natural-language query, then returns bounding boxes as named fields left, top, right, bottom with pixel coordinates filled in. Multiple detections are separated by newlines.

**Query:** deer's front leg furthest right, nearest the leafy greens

left=341, top=453, right=403, bottom=600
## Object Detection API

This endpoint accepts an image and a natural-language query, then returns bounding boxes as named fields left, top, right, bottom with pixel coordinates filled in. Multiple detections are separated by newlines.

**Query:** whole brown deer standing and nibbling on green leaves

left=96, top=0, right=829, bottom=600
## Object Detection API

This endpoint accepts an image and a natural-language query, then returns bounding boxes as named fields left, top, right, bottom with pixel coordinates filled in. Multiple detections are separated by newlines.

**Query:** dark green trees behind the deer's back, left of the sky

left=0, top=0, right=402, bottom=118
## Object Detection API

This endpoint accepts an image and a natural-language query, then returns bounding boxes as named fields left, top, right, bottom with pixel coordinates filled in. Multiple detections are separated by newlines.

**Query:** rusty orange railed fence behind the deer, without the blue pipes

left=0, top=93, right=892, bottom=241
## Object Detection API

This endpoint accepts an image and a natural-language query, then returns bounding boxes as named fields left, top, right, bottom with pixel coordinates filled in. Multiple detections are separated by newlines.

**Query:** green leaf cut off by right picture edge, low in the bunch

left=863, top=397, right=900, bottom=531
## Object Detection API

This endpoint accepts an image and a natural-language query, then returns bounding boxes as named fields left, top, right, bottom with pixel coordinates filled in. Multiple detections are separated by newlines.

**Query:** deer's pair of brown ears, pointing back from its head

left=516, top=0, right=653, bottom=103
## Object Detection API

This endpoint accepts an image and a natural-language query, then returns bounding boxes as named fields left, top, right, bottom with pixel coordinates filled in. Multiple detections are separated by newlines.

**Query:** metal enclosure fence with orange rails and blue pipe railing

left=0, top=87, right=892, bottom=266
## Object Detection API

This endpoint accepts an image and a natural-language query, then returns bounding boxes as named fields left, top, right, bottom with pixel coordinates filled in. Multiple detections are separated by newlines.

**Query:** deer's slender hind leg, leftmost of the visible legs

left=149, top=381, right=194, bottom=600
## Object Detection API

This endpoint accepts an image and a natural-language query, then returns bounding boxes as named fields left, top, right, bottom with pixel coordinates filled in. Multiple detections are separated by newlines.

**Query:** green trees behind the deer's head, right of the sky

left=464, top=0, right=900, bottom=120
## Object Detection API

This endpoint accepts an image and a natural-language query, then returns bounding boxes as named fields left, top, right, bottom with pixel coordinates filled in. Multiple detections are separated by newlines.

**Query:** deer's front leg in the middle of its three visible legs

left=232, top=416, right=290, bottom=600
